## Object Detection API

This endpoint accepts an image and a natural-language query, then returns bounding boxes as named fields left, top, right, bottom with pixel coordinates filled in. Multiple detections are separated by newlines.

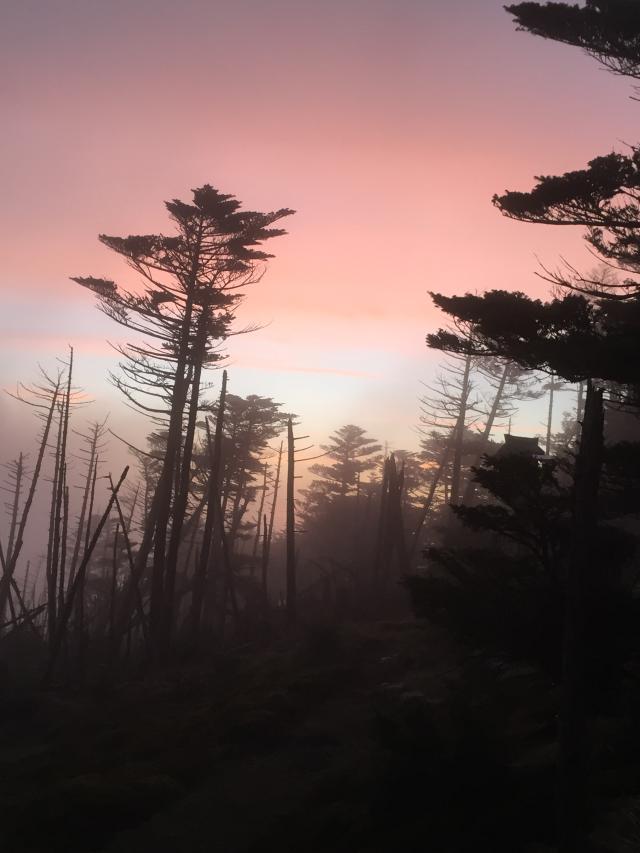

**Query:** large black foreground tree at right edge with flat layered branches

left=429, top=6, right=640, bottom=853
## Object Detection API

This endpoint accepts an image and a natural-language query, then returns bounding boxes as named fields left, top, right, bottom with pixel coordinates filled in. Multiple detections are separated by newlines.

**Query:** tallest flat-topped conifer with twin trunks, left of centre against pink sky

left=74, top=184, right=293, bottom=654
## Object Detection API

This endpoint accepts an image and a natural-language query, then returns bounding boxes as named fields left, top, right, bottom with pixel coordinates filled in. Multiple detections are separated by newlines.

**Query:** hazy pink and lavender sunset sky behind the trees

left=0, top=0, right=637, bottom=458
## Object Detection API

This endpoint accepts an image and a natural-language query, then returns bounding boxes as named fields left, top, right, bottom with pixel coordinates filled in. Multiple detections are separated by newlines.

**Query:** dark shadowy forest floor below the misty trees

left=0, top=621, right=640, bottom=853
